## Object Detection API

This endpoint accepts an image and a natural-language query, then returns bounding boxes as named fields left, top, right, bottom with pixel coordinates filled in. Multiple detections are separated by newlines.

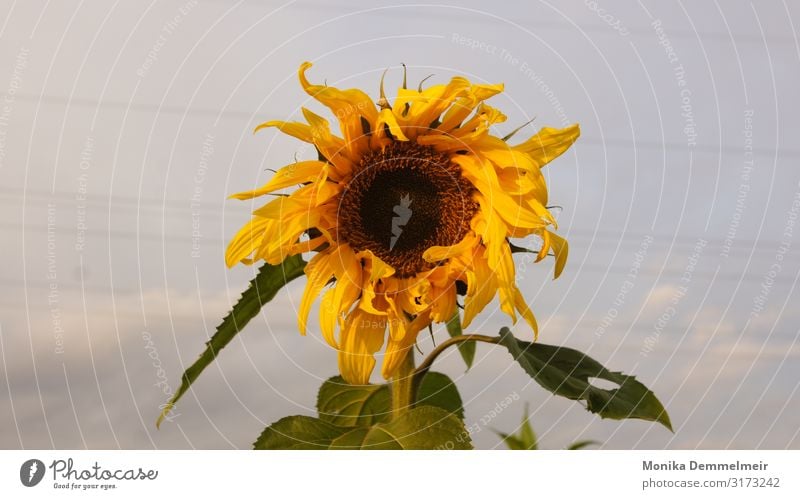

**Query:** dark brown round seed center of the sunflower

left=338, top=142, right=478, bottom=277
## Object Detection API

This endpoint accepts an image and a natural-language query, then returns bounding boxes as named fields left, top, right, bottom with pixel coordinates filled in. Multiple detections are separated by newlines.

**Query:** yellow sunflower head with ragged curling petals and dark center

left=226, top=62, right=580, bottom=384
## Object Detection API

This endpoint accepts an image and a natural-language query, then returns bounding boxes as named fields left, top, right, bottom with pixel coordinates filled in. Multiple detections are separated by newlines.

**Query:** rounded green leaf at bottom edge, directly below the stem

left=362, top=406, right=472, bottom=450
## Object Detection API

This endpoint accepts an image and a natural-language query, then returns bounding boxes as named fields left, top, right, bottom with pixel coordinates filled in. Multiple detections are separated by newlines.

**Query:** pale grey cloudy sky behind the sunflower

left=0, top=0, right=800, bottom=449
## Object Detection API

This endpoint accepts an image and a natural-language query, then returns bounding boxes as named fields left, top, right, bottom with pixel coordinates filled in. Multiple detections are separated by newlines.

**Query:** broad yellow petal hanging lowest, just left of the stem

left=339, top=308, right=386, bottom=385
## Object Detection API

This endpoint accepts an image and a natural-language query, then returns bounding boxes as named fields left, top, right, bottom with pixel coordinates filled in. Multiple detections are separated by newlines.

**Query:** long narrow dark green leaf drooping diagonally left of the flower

left=156, top=255, right=306, bottom=427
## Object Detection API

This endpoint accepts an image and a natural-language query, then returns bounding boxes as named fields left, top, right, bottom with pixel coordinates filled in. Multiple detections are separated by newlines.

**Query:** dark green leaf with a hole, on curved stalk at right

left=500, top=328, right=672, bottom=431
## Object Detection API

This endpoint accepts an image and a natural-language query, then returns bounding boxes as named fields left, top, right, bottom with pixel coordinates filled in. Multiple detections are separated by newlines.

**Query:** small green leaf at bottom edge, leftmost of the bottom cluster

left=253, top=416, right=350, bottom=450
